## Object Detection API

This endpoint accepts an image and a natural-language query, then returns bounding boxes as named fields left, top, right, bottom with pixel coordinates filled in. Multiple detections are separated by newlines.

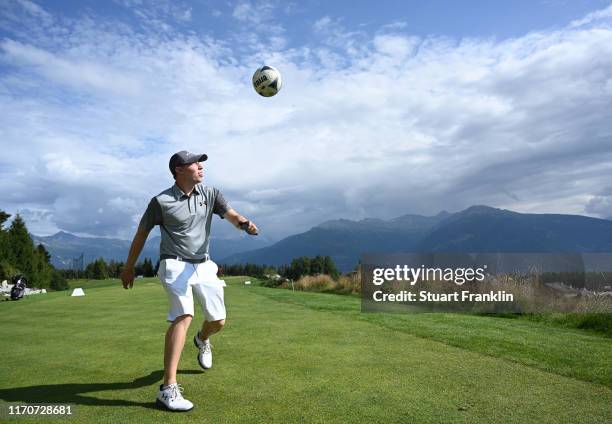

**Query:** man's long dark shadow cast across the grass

left=0, top=370, right=203, bottom=409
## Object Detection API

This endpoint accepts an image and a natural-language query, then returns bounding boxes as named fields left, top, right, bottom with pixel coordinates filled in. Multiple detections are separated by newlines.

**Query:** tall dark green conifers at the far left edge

left=0, top=211, right=68, bottom=290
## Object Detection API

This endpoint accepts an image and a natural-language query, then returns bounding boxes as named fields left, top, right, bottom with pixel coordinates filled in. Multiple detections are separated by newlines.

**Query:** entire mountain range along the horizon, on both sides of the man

left=32, top=206, right=612, bottom=272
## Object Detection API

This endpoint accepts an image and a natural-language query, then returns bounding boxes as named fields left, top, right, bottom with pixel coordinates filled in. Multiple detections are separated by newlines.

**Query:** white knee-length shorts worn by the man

left=157, top=259, right=226, bottom=322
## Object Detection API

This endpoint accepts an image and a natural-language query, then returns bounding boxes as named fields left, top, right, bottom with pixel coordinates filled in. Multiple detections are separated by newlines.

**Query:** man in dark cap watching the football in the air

left=121, top=151, right=258, bottom=411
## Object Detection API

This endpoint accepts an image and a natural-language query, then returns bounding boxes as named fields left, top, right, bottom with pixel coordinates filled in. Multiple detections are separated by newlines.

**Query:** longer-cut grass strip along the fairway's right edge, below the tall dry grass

left=253, top=287, right=612, bottom=388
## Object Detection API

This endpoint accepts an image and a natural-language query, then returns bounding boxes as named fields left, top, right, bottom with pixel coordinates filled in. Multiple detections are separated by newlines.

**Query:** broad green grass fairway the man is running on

left=0, top=277, right=612, bottom=423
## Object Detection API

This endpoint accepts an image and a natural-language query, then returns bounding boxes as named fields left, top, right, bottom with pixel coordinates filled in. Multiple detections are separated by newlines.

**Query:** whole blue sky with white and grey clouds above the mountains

left=0, top=0, right=612, bottom=241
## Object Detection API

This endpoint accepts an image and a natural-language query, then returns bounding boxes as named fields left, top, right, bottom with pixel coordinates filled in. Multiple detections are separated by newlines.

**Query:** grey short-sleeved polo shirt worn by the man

left=139, top=184, right=231, bottom=259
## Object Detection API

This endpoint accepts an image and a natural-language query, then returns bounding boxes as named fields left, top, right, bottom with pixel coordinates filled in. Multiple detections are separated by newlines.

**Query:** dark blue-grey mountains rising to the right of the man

left=221, top=206, right=612, bottom=272
